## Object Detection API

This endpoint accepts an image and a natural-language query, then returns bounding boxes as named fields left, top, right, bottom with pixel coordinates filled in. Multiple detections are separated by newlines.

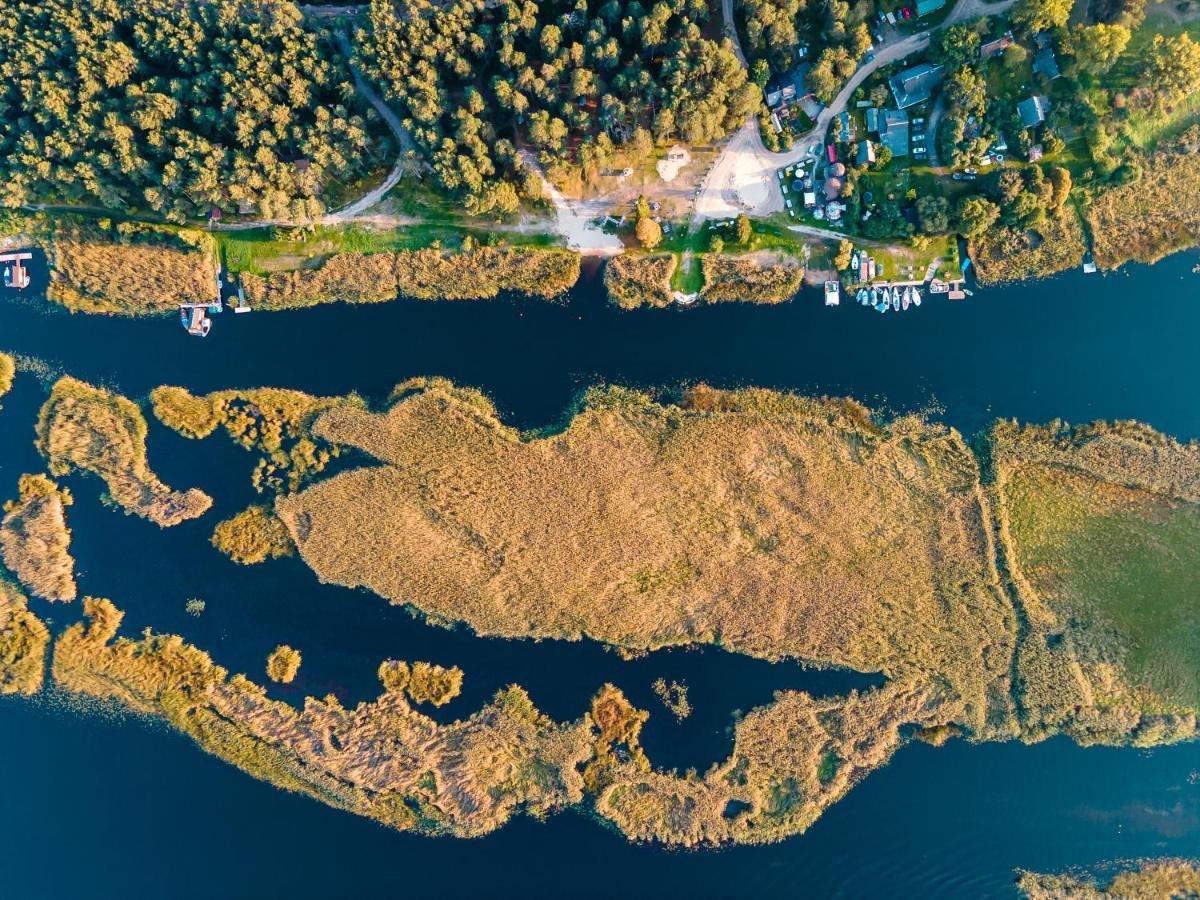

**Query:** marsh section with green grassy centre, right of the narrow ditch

left=990, top=422, right=1200, bottom=745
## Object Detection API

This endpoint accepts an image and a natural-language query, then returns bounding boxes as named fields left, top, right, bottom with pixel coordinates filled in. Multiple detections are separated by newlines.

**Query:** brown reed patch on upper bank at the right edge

left=1087, top=127, right=1200, bottom=269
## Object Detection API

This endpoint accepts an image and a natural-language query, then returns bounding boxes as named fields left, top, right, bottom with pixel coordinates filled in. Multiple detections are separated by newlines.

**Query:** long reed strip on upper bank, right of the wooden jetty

left=242, top=247, right=580, bottom=310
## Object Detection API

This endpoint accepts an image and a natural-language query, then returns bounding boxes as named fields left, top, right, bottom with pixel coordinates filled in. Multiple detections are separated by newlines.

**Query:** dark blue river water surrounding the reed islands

left=0, top=254, right=1200, bottom=898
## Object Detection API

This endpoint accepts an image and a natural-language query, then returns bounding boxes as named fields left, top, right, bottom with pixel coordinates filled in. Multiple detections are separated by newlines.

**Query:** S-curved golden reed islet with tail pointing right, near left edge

left=37, top=376, right=212, bottom=528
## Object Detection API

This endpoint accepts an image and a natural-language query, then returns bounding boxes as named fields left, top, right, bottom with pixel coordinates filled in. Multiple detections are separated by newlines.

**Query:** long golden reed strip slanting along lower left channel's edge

left=53, top=599, right=592, bottom=838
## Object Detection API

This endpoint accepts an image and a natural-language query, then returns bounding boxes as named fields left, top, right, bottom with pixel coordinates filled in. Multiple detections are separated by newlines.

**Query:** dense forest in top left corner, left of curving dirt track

left=0, top=0, right=384, bottom=221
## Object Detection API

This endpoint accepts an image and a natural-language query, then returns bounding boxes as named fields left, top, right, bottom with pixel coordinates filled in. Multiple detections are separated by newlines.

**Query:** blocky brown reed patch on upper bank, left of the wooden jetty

left=46, top=220, right=217, bottom=316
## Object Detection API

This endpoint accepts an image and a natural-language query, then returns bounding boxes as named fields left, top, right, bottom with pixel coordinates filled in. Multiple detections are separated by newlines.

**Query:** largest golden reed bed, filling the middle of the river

left=276, top=384, right=1013, bottom=721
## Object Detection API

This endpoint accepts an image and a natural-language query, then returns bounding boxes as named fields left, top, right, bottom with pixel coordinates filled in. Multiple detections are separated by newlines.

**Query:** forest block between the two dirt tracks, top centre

left=359, top=0, right=762, bottom=215
